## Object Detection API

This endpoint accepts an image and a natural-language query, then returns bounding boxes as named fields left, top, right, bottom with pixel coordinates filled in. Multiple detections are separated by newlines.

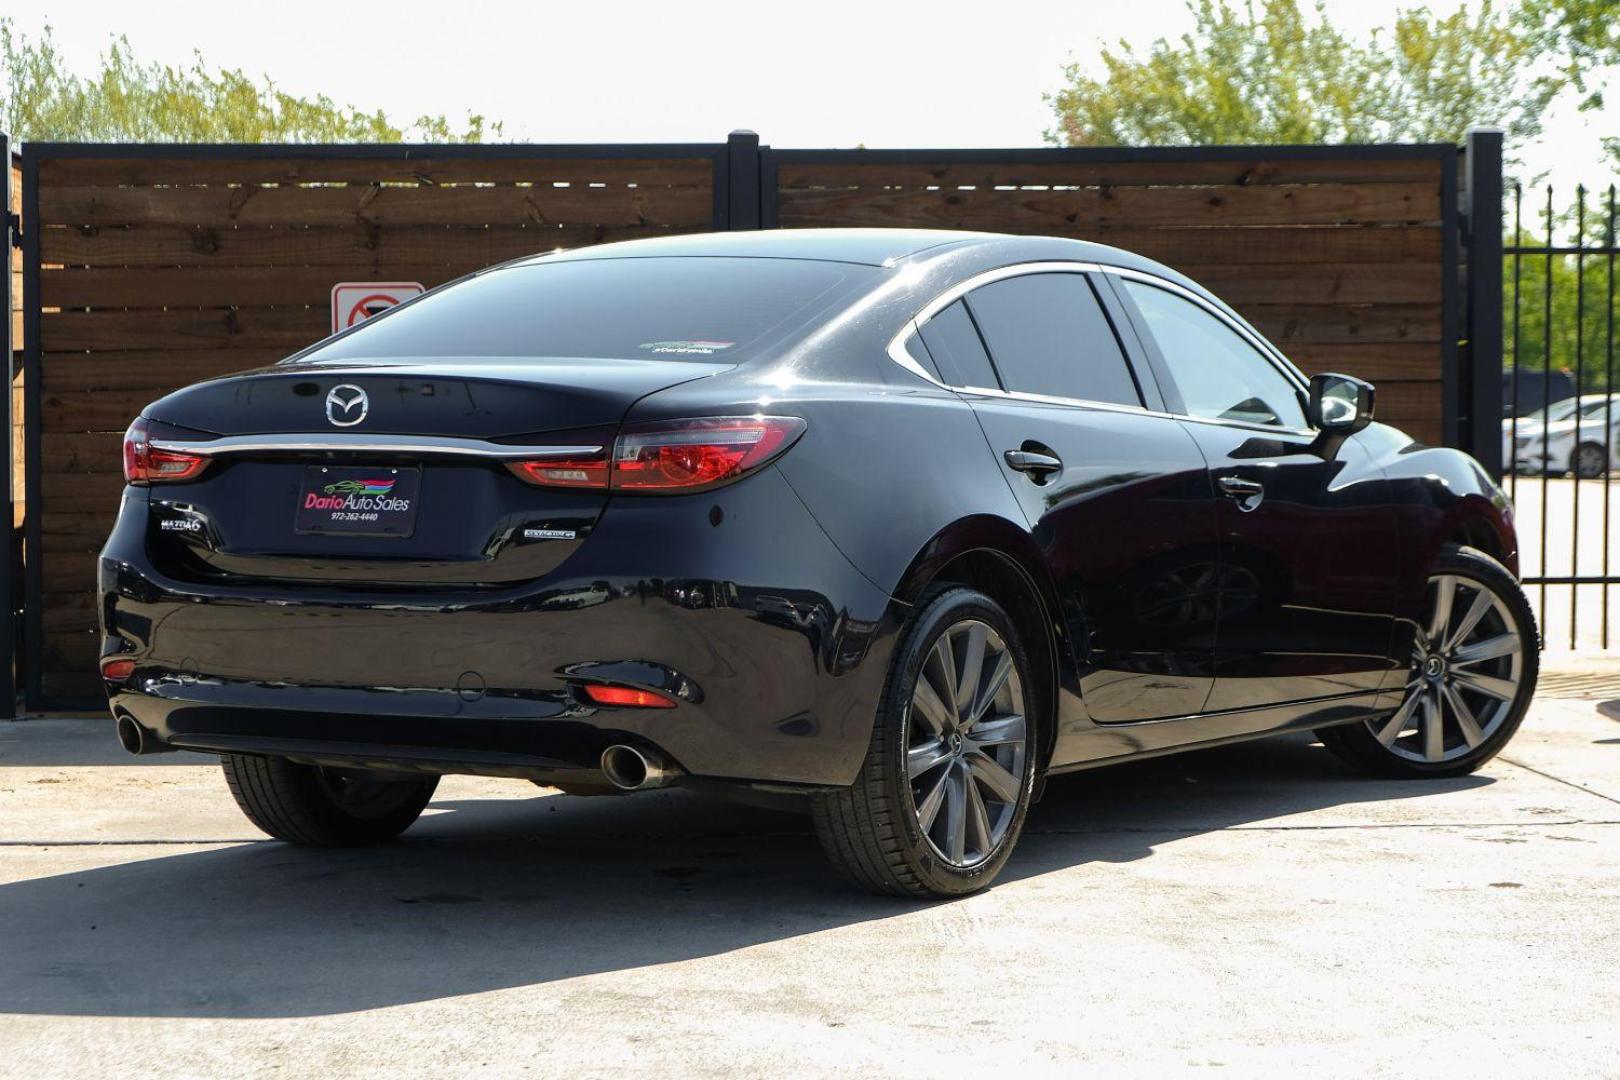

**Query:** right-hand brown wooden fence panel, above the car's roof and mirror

left=766, top=146, right=1455, bottom=444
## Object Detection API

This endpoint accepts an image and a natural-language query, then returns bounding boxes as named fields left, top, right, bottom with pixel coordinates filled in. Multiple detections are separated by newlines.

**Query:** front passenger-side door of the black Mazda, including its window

left=1110, top=272, right=1400, bottom=712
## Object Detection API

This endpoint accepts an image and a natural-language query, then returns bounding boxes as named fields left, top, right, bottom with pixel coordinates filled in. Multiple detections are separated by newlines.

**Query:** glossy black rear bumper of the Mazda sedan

left=100, top=470, right=899, bottom=785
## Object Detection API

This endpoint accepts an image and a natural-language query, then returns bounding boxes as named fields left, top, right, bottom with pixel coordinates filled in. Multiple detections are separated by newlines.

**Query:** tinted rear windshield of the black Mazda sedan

left=300, top=257, right=878, bottom=363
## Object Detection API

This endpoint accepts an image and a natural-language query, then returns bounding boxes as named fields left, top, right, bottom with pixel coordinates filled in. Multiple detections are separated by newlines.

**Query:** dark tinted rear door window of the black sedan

left=967, top=274, right=1142, bottom=405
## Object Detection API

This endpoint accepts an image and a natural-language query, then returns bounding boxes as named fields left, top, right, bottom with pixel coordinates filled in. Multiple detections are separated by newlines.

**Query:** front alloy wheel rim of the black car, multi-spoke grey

left=1367, top=573, right=1524, bottom=764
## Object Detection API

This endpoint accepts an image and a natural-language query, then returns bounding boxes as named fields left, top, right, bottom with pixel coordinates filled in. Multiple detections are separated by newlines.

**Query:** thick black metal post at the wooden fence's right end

left=1460, top=128, right=1518, bottom=479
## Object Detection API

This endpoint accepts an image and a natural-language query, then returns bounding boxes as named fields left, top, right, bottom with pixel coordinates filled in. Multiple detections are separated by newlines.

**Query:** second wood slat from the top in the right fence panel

left=778, top=185, right=1440, bottom=236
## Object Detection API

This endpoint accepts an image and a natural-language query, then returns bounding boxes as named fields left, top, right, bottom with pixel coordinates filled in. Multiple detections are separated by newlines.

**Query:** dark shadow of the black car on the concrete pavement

left=0, top=738, right=1490, bottom=1017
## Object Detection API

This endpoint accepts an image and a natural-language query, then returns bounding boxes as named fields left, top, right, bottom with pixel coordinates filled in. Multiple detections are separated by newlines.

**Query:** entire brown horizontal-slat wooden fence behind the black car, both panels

left=13, top=136, right=1490, bottom=706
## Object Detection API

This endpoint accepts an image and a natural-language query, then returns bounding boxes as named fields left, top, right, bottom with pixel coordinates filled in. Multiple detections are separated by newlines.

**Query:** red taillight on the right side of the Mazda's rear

left=507, top=416, right=805, bottom=494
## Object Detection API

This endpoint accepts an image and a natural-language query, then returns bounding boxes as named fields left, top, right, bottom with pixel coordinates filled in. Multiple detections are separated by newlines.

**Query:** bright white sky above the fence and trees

left=5, top=0, right=1620, bottom=185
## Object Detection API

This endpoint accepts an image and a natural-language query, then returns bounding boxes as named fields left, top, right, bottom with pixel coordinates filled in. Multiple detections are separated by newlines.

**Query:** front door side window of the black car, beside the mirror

left=1119, top=279, right=1306, bottom=427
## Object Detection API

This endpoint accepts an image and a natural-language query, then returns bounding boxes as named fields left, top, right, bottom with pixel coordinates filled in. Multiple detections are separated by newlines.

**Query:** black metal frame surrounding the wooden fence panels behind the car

left=0, top=130, right=1502, bottom=712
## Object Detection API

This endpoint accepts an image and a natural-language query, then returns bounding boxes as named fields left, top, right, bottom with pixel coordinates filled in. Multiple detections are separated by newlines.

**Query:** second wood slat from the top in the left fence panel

left=39, top=185, right=714, bottom=227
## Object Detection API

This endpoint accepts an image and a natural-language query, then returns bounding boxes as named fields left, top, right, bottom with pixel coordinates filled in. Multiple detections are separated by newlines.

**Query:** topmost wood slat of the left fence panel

left=39, top=154, right=714, bottom=188
